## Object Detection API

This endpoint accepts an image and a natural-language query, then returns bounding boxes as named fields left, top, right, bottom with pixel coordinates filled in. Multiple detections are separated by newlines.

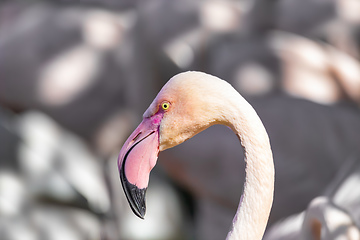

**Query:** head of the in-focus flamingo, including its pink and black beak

left=118, top=72, right=230, bottom=218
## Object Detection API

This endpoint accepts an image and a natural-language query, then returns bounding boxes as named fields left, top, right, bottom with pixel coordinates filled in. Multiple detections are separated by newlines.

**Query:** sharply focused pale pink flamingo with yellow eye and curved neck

left=118, top=72, right=275, bottom=240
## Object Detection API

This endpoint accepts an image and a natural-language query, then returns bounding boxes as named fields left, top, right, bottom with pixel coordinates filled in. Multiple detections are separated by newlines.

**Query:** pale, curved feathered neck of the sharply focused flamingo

left=226, top=95, right=274, bottom=240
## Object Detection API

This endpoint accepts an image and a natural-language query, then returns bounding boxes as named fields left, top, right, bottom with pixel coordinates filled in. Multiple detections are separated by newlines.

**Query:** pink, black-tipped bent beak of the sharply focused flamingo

left=118, top=118, right=159, bottom=219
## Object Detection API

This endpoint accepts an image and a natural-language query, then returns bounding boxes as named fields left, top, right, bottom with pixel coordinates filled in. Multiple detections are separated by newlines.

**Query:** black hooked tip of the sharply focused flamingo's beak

left=120, top=166, right=147, bottom=219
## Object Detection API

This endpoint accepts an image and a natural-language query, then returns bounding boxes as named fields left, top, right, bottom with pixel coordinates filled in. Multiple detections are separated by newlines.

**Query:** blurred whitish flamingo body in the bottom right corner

left=263, top=156, right=360, bottom=240
